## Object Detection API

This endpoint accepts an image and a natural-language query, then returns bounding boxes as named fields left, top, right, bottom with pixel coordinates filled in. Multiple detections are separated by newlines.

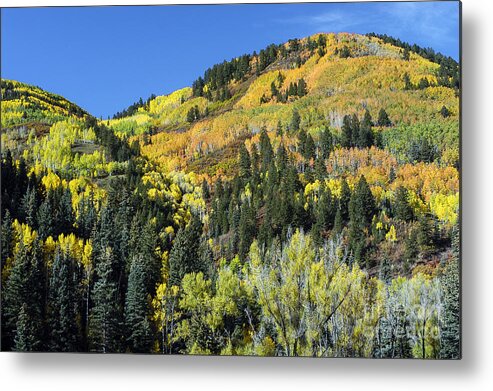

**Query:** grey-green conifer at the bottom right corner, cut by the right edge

left=440, top=224, right=461, bottom=359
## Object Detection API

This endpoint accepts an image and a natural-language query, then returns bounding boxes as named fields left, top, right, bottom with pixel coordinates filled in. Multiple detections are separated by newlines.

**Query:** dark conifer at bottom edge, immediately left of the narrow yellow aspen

left=125, top=255, right=153, bottom=353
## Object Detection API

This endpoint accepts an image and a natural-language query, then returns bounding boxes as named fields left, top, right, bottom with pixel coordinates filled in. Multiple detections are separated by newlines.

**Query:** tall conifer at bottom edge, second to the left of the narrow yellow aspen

left=88, top=247, right=122, bottom=353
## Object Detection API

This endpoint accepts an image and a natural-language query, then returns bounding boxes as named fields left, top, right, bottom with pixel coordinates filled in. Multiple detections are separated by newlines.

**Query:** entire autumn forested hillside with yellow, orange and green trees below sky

left=1, top=33, right=460, bottom=358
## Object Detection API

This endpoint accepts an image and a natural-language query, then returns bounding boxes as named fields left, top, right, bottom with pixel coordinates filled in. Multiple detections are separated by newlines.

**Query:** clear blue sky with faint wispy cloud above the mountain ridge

left=1, top=1, right=459, bottom=118
